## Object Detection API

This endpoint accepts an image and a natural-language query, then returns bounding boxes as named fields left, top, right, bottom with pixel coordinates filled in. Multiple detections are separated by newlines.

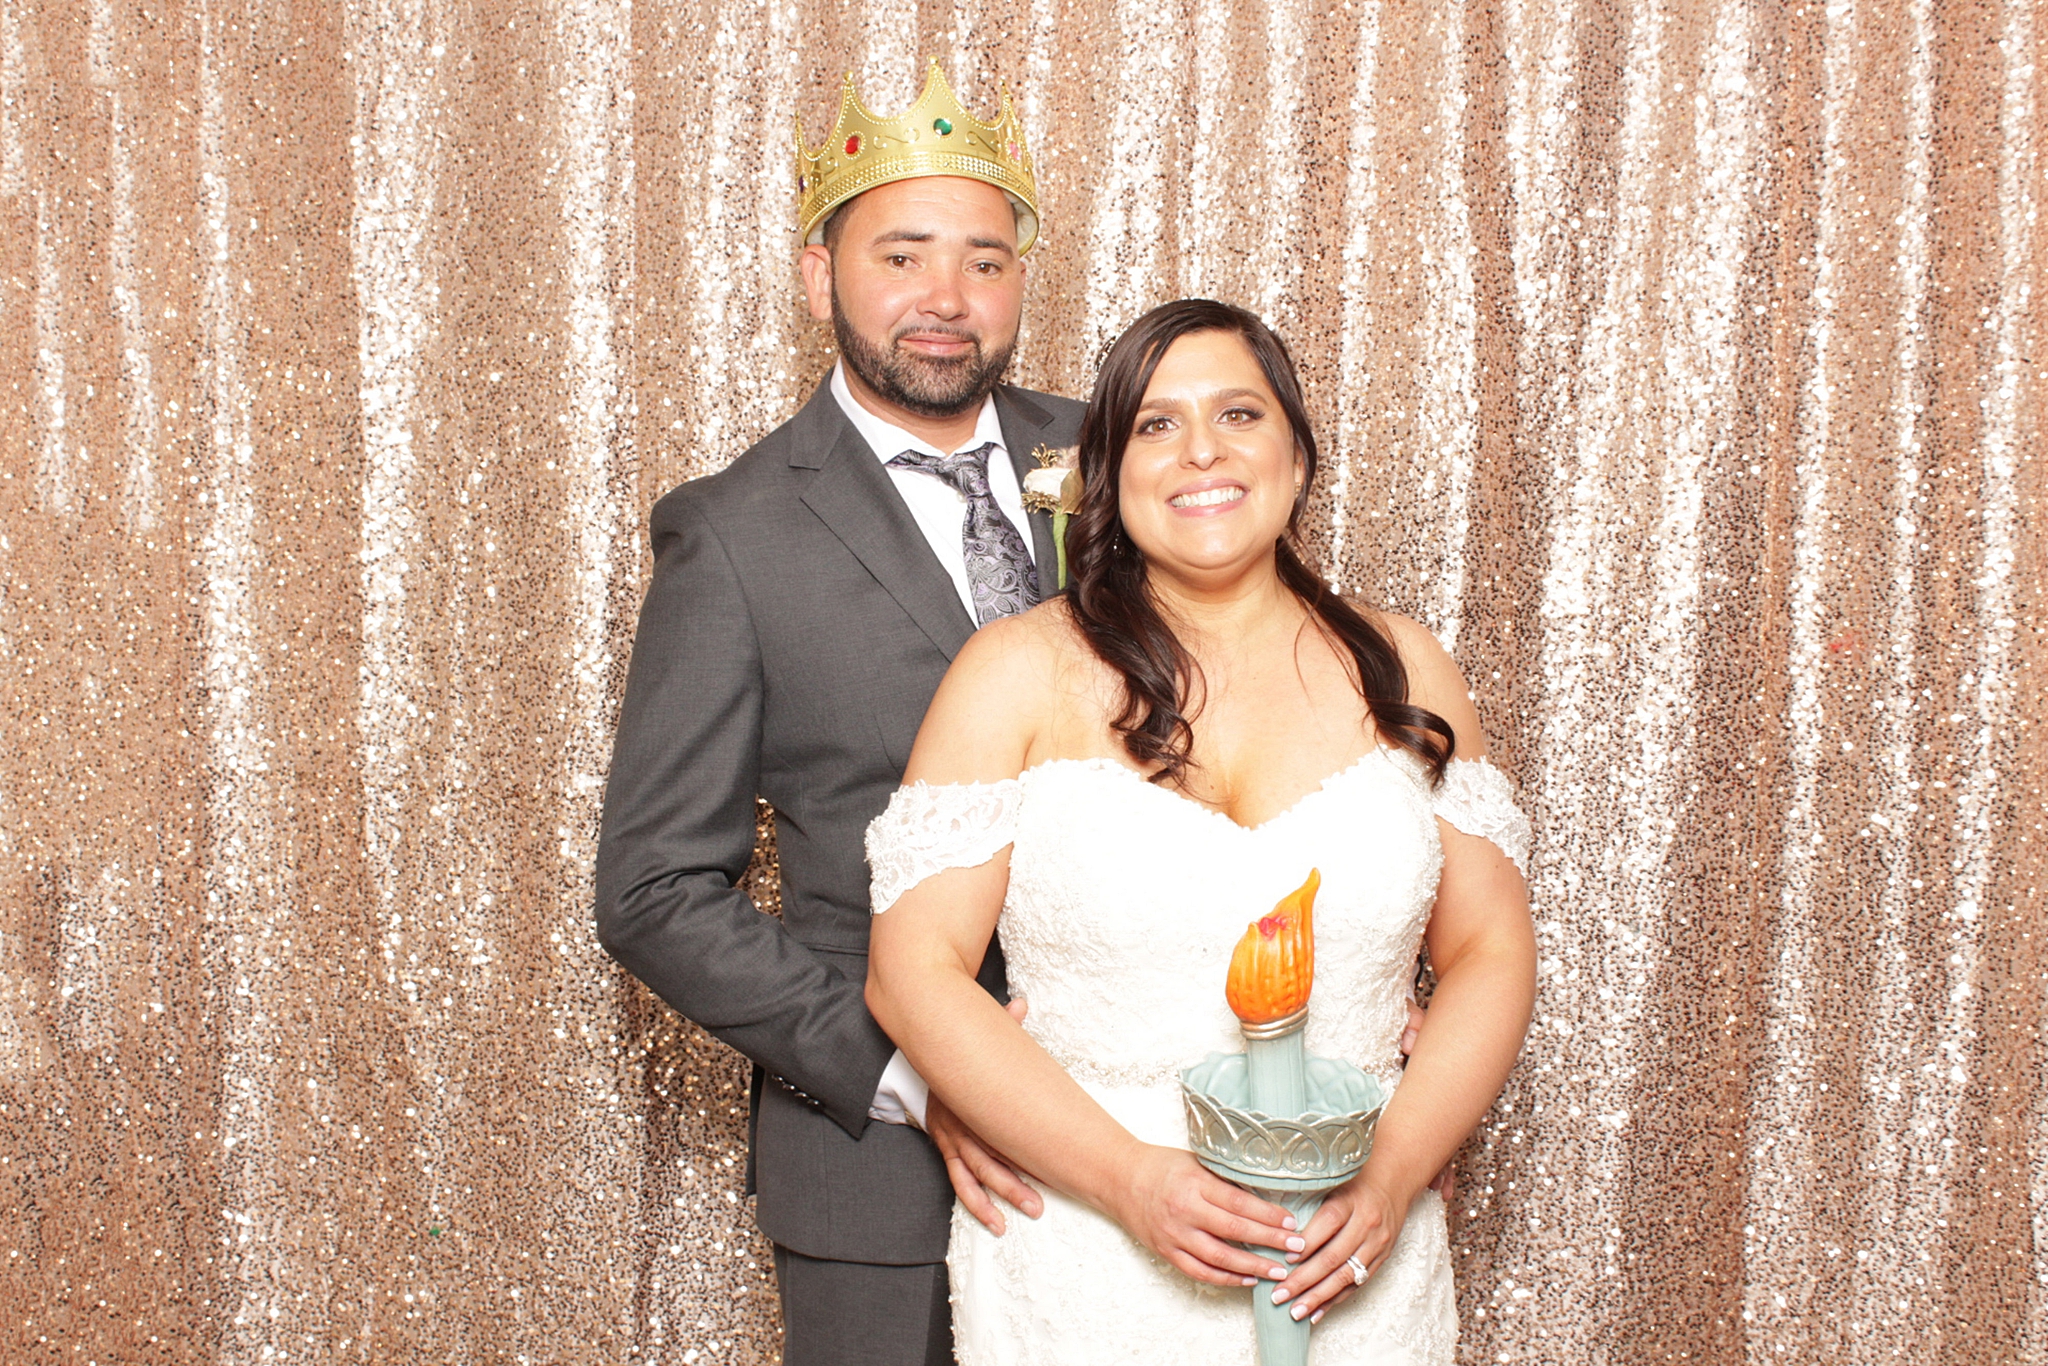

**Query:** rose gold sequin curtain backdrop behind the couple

left=0, top=0, right=2048, bottom=1366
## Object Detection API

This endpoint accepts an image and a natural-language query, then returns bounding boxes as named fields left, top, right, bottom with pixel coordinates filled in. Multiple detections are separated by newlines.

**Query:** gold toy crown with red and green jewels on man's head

left=797, top=57, right=1038, bottom=256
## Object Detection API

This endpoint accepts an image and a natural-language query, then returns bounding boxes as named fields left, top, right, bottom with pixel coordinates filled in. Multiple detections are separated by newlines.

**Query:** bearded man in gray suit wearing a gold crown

left=596, top=61, right=1081, bottom=1366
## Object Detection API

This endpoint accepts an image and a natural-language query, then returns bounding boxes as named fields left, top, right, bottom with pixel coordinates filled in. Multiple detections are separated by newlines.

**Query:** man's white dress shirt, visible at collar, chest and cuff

left=831, top=360, right=1036, bottom=1128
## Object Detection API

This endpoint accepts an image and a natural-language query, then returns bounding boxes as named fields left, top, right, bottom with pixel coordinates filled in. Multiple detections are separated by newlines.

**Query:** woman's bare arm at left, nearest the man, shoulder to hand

left=866, top=610, right=1303, bottom=1286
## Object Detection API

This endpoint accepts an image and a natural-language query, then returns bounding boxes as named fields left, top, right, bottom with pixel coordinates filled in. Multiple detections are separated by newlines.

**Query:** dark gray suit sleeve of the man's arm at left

left=596, top=485, right=895, bottom=1139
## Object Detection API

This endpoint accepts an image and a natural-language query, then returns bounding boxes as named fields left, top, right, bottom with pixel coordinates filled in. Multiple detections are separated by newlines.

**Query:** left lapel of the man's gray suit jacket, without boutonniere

left=788, top=379, right=975, bottom=659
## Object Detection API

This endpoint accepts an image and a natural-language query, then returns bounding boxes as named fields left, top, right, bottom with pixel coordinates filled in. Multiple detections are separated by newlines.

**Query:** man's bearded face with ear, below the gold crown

left=803, top=176, right=1024, bottom=418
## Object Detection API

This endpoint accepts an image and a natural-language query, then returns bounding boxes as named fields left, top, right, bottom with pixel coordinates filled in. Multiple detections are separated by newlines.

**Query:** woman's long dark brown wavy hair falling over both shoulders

left=1067, top=299, right=1456, bottom=784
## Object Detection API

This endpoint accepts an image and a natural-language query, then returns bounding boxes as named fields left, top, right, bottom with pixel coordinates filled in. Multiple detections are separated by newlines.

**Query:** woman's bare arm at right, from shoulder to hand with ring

left=1276, top=618, right=1536, bottom=1317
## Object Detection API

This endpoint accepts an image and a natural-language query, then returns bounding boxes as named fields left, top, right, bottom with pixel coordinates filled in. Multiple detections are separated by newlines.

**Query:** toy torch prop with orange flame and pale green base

left=1180, top=868, right=1384, bottom=1366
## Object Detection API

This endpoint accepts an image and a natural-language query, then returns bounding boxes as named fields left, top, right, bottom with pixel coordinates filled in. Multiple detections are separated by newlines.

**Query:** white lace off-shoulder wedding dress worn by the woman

left=868, top=750, right=1530, bottom=1366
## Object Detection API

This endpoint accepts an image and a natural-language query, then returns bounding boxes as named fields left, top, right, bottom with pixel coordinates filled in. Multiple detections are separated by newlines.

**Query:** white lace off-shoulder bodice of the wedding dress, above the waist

left=868, top=750, right=1530, bottom=1085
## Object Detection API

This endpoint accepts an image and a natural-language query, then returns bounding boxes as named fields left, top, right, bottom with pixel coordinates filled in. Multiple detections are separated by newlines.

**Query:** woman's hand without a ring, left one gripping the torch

left=1108, top=1145, right=1309, bottom=1286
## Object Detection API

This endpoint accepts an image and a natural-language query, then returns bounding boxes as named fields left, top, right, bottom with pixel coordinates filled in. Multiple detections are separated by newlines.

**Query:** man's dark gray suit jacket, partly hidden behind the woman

left=596, top=383, right=1081, bottom=1264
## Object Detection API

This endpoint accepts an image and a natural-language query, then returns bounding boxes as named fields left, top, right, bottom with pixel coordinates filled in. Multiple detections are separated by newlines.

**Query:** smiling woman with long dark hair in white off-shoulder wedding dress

left=868, top=299, right=1536, bottom=1366
